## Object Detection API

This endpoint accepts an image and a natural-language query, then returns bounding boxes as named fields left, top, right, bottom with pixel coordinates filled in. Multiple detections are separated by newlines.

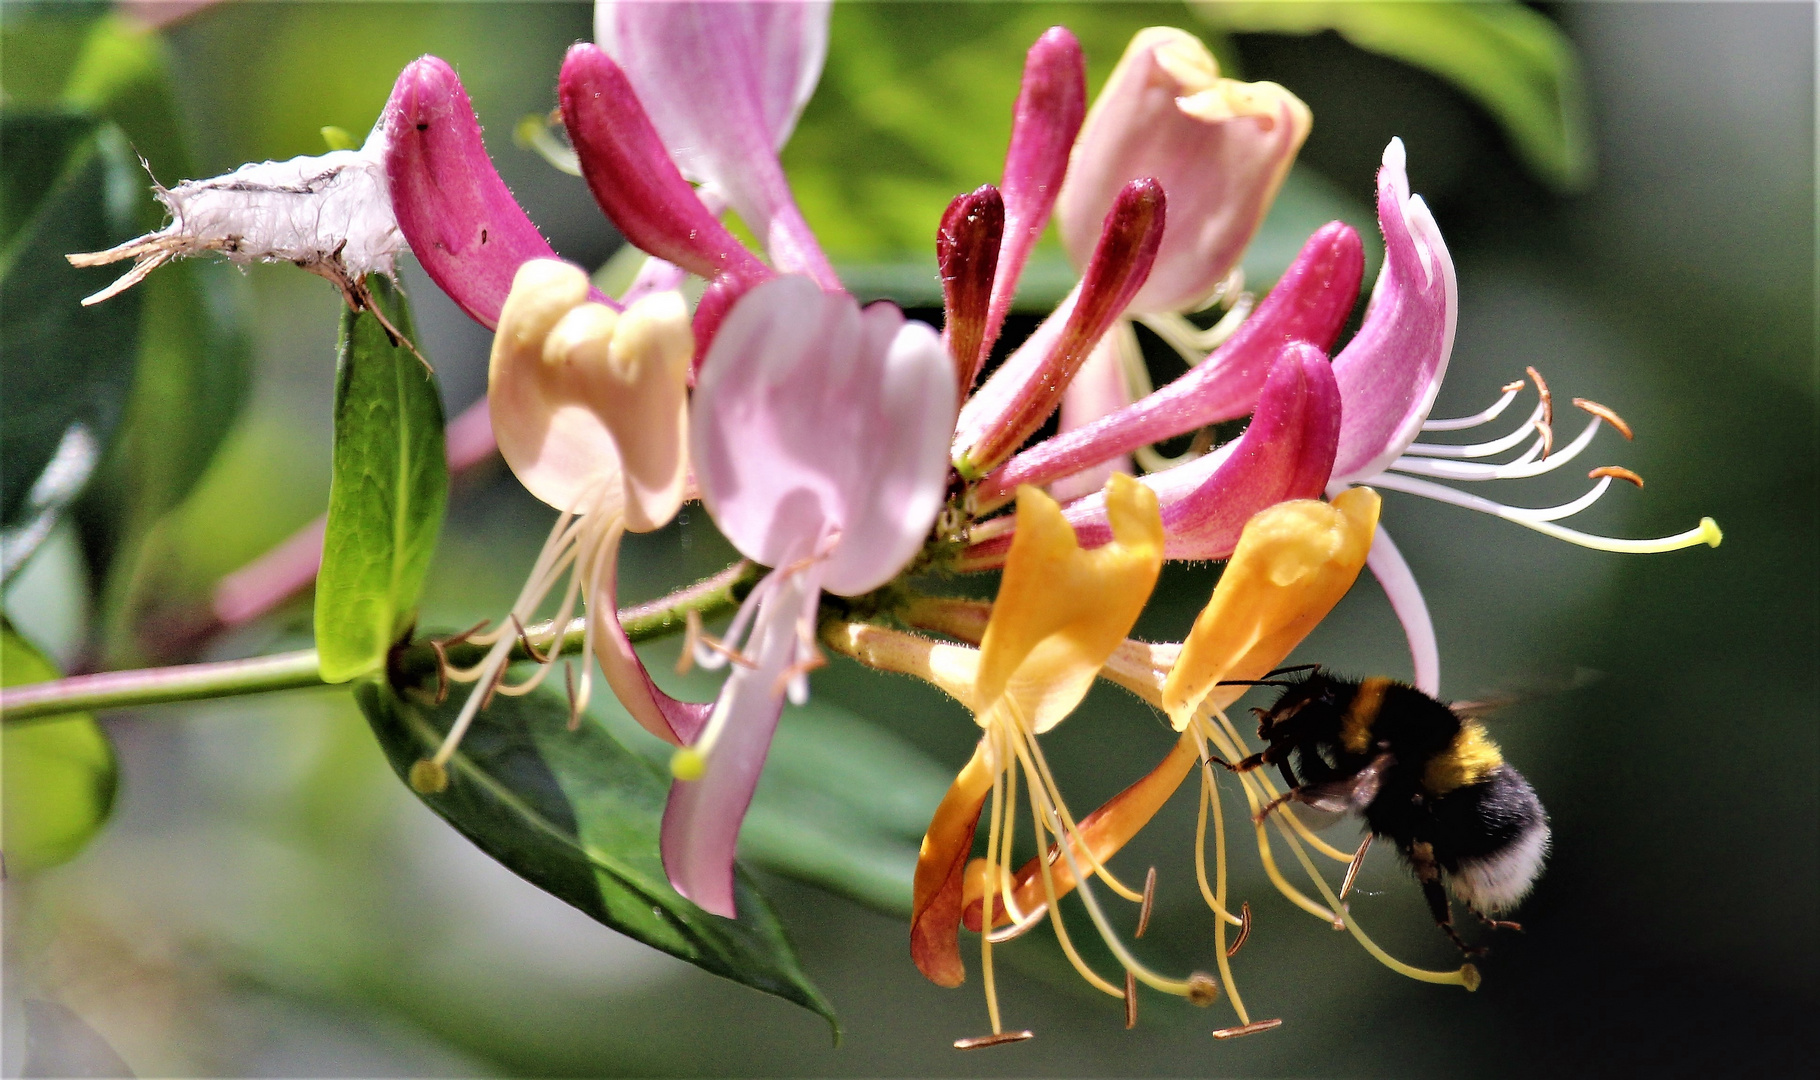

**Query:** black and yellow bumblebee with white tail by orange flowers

left=1229, top=665, right=1549, bottom=956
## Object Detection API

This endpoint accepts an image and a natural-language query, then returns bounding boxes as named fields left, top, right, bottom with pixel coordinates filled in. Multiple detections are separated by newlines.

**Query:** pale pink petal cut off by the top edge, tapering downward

left=595, top=0, right=841, bottom=290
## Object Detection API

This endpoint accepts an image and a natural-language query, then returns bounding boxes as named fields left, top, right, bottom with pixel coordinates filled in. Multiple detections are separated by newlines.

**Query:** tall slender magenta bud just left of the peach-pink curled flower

left=977, top=25, right=1087, bottom=364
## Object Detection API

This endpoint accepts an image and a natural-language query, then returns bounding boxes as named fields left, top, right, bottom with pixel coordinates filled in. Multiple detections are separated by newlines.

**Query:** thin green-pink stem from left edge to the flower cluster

left=0, top=563, right=757, bottom=723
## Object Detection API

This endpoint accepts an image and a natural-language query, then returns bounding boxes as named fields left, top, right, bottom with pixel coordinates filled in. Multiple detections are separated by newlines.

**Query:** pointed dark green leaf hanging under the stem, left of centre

left=355, top=683, right=839, bottom=1034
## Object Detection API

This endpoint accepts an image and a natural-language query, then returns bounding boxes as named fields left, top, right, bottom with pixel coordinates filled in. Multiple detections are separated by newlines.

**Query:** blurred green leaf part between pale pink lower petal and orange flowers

left=739, top=701, right=954, bottom=914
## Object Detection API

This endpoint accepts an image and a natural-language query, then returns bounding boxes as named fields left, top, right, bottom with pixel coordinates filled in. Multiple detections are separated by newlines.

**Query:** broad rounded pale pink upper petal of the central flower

left=692, top=275, right=954, bottom=596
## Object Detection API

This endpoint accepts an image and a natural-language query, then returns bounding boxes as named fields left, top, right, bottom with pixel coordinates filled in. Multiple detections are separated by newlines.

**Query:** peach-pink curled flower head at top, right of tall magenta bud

left=1056, top=27, right=1312, bottom=313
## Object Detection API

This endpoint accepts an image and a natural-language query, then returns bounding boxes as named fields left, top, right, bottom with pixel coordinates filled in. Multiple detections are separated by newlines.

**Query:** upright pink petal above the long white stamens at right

left=1334, top=138, right=1460, bottom=481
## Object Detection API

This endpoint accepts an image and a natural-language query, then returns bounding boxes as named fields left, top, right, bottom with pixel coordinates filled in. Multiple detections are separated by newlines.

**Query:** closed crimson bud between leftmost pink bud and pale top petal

left=557, top=44, right=772, bottom=282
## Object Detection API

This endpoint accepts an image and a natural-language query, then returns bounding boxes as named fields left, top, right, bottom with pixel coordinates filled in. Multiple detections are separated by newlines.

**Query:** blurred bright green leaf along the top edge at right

left=1190, top=0, right=1594, bottom=191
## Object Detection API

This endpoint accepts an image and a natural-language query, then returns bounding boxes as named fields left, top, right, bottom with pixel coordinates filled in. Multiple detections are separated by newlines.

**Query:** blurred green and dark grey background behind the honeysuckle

left=4, top=4, right=1820, bottom=1076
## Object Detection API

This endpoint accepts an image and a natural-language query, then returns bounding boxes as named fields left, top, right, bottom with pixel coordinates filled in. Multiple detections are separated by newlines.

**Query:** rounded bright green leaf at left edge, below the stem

left=0, top=623, right=118, bottom=874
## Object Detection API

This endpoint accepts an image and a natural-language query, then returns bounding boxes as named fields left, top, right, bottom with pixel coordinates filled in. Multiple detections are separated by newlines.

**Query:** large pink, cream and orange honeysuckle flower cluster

left=70, top=2, right=1720, bottom=1047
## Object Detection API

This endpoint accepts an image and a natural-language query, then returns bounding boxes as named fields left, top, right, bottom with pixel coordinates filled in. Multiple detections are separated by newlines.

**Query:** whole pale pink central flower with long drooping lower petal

left=662, top=275, right=954, bottom=916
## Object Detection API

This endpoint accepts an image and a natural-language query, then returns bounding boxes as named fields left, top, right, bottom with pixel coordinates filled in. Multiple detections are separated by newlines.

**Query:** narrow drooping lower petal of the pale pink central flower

left=661, top=568, right=821, bottom=918
